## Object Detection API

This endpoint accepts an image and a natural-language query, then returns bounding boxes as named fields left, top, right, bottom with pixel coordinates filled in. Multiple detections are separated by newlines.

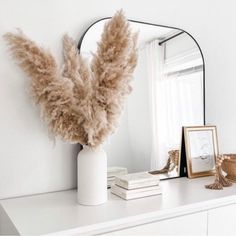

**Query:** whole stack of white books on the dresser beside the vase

left=111, top=172, right=162, bottom=200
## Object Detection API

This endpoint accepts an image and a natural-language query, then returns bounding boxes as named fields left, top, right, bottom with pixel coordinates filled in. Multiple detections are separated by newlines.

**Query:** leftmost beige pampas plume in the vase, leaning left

left=4, top=31, right=87, bottom=144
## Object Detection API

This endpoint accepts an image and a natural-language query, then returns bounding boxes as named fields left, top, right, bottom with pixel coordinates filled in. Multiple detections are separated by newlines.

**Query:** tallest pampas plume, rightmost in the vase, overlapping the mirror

left=89, top=11, right=137, bottom=145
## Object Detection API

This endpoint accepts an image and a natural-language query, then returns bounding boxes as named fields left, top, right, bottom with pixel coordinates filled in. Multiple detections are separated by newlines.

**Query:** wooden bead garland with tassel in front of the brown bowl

left=205, top=155, right=232, bottom=190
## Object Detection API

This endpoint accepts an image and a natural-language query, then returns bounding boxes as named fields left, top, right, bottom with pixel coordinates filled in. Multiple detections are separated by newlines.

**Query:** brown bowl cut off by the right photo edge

left=221, top=154, right=236, bottom=183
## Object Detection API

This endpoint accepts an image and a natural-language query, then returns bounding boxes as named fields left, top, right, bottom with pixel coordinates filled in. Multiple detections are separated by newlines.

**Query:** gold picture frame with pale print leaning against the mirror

left=184, top=126, right=219, bottom=178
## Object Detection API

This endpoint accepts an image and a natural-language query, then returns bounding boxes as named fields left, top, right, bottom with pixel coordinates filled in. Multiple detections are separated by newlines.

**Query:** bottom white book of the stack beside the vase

left=111, top=185, right=162, bottom=200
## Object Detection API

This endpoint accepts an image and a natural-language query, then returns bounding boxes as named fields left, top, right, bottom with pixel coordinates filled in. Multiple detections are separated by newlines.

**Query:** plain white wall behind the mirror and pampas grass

left=0, top=0, right=236, bottom=198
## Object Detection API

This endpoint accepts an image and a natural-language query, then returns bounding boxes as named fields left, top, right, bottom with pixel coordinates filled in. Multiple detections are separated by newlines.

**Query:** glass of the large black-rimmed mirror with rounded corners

left=79, top=19, right=204, bottom=178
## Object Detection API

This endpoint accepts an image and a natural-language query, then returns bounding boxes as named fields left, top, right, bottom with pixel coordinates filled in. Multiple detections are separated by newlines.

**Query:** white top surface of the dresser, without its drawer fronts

left=0, top=177, right=236, bottom=235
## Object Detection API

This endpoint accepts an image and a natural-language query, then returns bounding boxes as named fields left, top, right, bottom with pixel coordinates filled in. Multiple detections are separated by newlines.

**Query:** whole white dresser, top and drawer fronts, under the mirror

left=0, top=177, right=236, bottom=236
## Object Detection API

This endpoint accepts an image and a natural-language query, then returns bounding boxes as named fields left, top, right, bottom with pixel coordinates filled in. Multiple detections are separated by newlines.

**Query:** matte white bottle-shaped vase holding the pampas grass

left=77, top=146, right=107, bottom=205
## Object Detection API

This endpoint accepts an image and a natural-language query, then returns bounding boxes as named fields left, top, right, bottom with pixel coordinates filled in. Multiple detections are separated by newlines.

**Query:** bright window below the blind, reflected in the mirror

left=157, top=72, right=203, bottom=168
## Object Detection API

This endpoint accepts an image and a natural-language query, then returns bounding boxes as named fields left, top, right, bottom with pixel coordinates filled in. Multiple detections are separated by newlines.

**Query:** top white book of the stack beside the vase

left=115, top=172, right=160, bottom=189
